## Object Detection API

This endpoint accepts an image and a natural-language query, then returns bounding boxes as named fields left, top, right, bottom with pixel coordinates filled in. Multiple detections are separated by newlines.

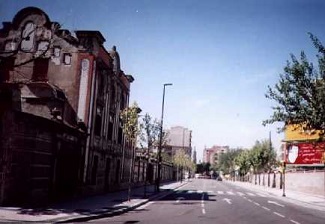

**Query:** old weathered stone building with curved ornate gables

left=0, top=7, right=133, bottom=203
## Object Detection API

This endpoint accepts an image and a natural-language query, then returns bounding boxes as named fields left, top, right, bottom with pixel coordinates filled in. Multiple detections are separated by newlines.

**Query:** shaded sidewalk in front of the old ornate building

left=0, top=181, right=187, bottom=223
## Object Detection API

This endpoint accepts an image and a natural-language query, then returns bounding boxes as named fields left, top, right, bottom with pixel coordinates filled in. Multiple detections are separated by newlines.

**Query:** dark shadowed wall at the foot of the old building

left=0, top=111, right=84, bottom=205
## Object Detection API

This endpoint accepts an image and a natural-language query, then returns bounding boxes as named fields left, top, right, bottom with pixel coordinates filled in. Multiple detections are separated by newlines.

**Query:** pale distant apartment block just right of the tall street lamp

left=164, top=126, right=192, bottom=158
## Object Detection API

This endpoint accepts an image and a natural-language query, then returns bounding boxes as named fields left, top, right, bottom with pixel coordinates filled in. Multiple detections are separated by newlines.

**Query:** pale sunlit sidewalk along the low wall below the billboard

left=227, top=181, right=325, bottom=211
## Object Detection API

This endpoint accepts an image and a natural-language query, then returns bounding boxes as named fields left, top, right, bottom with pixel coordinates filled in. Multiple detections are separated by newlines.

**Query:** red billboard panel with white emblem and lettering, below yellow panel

left=285, top=142, right=325, bottom=164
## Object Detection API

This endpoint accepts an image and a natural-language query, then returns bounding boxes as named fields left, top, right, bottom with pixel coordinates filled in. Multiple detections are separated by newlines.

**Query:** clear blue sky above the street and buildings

left=0, top=0, right=325, bottom=160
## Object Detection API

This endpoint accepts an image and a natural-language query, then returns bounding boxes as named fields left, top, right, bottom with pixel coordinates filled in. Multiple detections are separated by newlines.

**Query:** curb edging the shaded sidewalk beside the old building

left=52, top=182, right=188, bottom=223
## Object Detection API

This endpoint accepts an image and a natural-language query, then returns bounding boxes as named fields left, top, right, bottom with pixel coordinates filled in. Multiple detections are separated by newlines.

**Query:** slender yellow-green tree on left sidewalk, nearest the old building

left=120, top=102, right=141, bottom=201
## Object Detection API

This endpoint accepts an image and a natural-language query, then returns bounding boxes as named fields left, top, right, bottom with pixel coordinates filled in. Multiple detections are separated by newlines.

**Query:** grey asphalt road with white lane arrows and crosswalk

left=92, top=179, right=325, bottom=224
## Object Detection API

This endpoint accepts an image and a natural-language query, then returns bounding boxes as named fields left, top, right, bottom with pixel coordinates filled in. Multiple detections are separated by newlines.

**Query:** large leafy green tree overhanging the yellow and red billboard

left=263, top=33, right=325, bottom=138
